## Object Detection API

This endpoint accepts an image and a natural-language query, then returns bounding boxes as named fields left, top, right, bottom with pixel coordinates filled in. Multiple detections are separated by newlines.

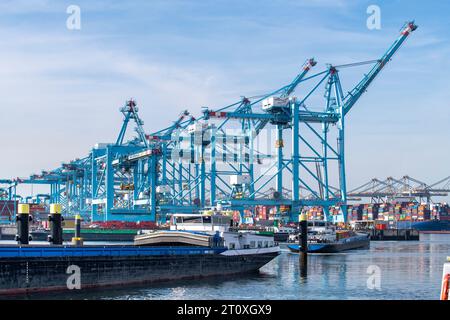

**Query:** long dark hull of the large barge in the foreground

left=0, top=248, right=279, bottom=295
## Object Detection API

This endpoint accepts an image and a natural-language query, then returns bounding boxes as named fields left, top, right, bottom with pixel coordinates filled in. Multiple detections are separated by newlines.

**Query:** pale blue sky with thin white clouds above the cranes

left=0, top=0, right=450, bottom=199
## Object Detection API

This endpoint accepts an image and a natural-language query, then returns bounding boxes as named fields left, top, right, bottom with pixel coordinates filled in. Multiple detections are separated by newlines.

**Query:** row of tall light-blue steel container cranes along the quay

left=0, top=22, right=417, bottom=221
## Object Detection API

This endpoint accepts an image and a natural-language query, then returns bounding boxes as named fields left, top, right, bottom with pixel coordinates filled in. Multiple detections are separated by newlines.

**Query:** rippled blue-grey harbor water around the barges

left=4, top=234, right=450, bottom=300
